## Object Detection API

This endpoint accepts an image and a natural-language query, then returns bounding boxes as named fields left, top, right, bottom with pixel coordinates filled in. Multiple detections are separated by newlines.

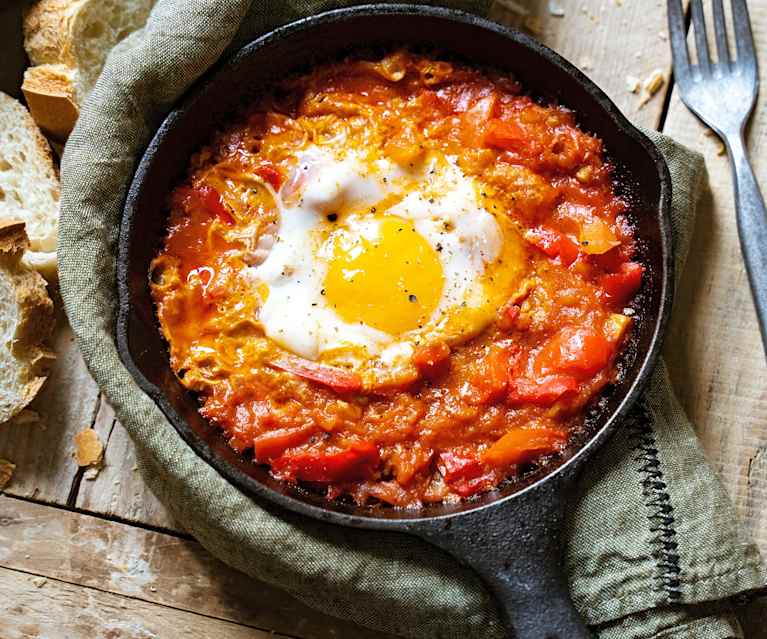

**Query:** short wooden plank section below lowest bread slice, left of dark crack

left=0, top=308, right=98, bottom=504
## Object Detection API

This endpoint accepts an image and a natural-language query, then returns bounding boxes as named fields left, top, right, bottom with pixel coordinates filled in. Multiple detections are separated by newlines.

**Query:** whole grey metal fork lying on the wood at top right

left=668, top=0, right=767, bottom=352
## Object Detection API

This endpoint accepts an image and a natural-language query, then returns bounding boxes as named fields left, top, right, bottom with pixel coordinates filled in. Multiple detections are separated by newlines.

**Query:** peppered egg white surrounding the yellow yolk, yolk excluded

left=246, top=146, right=504, bottom=378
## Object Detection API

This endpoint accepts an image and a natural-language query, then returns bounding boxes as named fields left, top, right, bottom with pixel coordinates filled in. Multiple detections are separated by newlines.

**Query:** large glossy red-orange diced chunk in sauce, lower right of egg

left=533, top=326, right=614, bottom=379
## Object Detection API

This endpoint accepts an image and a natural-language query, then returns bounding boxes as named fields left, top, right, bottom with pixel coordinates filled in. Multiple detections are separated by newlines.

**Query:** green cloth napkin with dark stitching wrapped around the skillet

left=59, top=0, right=767, bottom=639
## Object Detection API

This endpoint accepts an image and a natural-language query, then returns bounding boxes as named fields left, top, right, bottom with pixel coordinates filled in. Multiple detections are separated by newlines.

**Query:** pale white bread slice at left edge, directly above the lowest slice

left=0, top=92, right=59, bottom=279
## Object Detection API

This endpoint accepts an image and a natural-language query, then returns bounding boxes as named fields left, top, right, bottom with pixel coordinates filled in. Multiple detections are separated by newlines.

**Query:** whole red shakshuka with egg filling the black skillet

left=149, top=51, right=643, bottom=507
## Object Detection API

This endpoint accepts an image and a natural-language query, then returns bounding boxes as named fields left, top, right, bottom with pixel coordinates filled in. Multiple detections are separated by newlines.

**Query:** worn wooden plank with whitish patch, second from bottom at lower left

left=0, top=496, right=396, bottom=639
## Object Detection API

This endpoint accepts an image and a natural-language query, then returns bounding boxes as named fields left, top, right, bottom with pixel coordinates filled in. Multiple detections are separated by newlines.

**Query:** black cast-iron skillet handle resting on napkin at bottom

left=413, top=476, right=593, bottom=639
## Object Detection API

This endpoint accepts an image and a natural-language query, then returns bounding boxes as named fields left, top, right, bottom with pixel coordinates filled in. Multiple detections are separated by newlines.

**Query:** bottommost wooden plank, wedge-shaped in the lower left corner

left=0, top=568, right=287, bottom=639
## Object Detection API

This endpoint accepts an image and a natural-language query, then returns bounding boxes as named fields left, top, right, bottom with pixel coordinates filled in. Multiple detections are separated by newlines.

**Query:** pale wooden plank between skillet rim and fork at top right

left=490, top=0, right=671, bottom=128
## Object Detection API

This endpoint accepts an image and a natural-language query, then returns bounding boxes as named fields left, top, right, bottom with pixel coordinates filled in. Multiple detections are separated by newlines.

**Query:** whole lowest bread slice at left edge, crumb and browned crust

left=0, top=222, right=55, bottom=424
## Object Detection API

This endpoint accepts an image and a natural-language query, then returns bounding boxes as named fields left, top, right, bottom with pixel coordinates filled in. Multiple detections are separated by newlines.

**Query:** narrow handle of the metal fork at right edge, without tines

left=727, top=131, right=767, bottom=353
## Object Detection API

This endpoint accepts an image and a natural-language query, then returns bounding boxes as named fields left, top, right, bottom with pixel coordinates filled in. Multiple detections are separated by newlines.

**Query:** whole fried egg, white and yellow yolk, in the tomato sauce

left=246, top=146, right=525, bottom=386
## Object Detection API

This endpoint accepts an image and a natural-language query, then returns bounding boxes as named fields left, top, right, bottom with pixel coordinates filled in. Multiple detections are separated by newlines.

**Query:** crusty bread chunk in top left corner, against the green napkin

left=22, top=0, right=154, bottom=142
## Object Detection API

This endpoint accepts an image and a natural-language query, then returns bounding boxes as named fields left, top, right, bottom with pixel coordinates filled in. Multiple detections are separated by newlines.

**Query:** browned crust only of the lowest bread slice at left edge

left=0, top=221, right=55, bottom=423
